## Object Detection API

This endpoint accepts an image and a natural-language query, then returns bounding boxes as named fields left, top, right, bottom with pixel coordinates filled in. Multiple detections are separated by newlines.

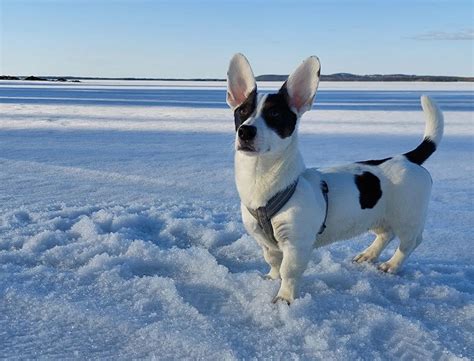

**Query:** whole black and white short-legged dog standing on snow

left=227, top=54, right=443, bottom=303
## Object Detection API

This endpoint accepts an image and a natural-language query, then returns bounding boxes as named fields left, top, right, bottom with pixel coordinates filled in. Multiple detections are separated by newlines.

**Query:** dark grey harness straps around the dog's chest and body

left=247, top=179, right=329, bottom=245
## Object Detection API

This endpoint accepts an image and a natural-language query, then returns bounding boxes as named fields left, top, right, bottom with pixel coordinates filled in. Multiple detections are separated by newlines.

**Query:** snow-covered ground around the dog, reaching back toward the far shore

left=0, top=82, right=474, bottom=360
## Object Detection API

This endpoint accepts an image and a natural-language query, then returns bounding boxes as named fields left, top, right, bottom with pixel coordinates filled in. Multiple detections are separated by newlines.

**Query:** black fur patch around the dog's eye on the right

left=262, top=82, right=298, bottom=138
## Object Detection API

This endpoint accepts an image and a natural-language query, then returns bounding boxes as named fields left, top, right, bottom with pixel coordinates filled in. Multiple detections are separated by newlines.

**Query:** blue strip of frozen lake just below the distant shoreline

left=0, top=82, right=474, bottom=111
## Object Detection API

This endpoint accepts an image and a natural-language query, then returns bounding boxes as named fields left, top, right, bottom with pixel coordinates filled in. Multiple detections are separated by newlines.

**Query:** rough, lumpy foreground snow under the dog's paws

left=0, top=203, right=474, bottom=359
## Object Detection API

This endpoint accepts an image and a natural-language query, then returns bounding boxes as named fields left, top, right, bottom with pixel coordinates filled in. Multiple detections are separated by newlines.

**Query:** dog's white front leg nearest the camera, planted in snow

left=272, top=241, right=313, bottom=304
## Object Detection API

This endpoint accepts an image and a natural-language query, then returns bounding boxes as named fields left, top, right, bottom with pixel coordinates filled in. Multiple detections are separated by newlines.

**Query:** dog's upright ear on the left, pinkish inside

left=227, top=53, right=257, bottom=110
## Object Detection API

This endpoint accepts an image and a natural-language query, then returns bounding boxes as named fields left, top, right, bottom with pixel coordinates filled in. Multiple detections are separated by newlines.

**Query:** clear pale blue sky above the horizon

left=0, top=0, right=474, bottom=78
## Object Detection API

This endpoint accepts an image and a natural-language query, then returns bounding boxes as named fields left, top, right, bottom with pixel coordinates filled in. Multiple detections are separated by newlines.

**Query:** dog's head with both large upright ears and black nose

left=227, top=54, right=320, bottom=156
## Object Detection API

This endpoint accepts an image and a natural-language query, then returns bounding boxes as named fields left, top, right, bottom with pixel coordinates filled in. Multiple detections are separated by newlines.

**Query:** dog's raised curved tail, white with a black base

left=404, top=95, right=444, bottom=165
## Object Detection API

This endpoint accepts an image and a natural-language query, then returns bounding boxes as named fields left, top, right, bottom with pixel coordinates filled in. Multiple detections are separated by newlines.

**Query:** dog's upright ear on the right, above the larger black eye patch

left=280, top=56, right=321, bottom=116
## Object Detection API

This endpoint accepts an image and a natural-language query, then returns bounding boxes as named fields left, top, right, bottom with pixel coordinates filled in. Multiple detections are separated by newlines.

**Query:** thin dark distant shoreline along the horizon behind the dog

left=0, top=73, right=474, bottom=83
